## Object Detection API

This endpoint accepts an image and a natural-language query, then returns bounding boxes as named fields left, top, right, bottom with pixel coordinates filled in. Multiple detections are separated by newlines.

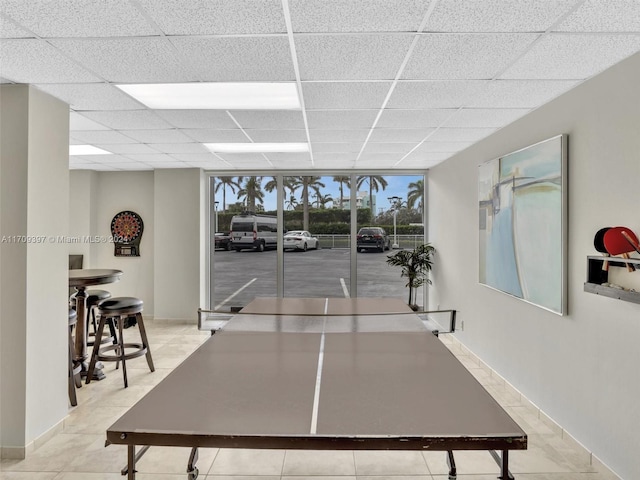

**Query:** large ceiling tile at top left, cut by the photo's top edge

left=2, top=0, right=159, bottom=38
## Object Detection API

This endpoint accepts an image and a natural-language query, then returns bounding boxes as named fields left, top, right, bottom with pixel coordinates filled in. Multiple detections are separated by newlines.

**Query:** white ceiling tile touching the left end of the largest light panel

left=36, top=83, right=144, bottom=110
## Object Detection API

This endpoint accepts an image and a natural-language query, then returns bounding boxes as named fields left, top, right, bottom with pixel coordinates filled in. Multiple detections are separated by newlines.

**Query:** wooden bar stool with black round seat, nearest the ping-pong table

left=87, top=297, right=155, bottom=388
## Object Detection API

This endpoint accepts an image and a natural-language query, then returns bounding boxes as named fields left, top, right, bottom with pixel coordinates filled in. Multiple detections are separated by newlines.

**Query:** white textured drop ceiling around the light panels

left=0, top=0, right=640, bottom=171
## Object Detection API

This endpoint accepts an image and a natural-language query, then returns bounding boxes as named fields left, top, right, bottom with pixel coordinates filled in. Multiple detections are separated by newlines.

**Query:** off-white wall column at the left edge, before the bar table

left=0, top=85, right=69, bottom=456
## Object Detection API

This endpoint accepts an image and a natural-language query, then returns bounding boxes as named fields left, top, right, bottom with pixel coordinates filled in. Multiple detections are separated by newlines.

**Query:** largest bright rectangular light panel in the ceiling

left=116, top=82, right=300, bottom=110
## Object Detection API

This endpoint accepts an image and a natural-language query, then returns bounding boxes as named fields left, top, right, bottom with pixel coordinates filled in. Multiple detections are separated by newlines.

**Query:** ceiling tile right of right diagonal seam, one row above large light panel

left=402, top=33, right=539, bottom=80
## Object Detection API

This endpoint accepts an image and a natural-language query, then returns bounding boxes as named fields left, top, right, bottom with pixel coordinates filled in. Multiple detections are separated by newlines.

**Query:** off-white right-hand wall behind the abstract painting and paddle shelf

left=428, top=50, right=640, bottom=479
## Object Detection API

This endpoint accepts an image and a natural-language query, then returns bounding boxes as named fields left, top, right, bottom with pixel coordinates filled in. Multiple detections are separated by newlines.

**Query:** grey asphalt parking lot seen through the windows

left=212, top=248, right=423, bottom=309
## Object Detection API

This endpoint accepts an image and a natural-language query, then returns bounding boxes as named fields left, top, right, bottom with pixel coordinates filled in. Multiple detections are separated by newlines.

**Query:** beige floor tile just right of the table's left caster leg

left=209, top=448, right=285, bottom=475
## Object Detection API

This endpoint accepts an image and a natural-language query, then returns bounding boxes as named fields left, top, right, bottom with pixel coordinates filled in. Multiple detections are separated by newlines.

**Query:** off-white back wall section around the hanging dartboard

left=69, top=169, right=207, bottom=324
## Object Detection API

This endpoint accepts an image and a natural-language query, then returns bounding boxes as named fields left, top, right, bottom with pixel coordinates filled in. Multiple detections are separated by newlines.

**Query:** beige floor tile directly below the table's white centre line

left=282, top=450, right=356, bottom=476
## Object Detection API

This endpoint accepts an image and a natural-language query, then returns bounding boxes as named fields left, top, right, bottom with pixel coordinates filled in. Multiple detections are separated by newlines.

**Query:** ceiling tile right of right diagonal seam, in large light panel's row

left=387, top=80, right=486, bottom=108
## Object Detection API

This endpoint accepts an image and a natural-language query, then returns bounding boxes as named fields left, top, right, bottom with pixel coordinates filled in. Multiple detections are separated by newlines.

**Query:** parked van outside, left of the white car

left=229, top=213, right=278, bottom=252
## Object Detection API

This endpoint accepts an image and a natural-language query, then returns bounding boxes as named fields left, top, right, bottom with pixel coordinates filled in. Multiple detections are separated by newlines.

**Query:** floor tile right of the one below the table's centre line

left=354, top=450, right=429, bottom=476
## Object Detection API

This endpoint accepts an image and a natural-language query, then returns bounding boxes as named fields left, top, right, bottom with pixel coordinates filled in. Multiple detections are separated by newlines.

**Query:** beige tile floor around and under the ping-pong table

left=0, top=321, right=618, bottom=480
